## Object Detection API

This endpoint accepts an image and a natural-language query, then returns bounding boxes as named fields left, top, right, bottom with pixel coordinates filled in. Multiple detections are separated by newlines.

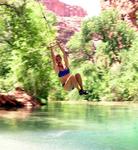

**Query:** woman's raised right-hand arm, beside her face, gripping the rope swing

left=57, top=42, right=69, bottom=68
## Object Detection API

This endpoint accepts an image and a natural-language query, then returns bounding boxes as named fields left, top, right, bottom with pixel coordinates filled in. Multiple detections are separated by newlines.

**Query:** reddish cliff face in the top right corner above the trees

left=101, top=0, right=138, bottom=30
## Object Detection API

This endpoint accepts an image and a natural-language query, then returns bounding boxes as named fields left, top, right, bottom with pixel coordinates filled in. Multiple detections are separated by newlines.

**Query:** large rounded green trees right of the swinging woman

left=68, top=10, right=138, bottom=101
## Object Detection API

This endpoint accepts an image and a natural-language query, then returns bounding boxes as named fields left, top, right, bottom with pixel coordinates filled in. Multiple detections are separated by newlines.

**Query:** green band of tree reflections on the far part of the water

left=0, top=103, right=138, bottom=130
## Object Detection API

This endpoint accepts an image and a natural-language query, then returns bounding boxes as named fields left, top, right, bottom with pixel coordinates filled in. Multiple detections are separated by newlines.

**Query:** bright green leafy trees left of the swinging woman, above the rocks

left=0, top=0, right=56, bottom=102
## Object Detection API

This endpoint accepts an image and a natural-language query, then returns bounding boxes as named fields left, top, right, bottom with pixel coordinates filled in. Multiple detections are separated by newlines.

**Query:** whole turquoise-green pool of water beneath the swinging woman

left=0, top=103, right=138, bottom=150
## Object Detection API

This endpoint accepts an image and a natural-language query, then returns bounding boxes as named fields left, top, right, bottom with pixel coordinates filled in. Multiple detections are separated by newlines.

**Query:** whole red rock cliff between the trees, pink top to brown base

left=43, top=0, right=87, bottom=44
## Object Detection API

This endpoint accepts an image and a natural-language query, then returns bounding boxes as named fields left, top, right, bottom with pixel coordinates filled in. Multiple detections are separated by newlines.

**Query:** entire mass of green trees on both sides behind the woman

left=0, top=0, right=138, bottom=101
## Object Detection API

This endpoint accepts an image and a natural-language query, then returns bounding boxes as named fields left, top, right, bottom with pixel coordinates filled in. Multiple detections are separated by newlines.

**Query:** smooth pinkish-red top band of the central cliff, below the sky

left=43, top=0, right=87, bottom=17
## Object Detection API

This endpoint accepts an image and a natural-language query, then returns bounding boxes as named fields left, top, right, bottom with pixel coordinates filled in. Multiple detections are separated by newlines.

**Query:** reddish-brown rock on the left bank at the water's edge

left=0, top=87, right=41, bottom=108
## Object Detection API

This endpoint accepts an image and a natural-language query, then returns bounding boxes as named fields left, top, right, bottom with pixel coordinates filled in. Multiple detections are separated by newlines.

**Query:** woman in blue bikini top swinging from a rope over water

left=50, top=42, right=88, bottom=95
